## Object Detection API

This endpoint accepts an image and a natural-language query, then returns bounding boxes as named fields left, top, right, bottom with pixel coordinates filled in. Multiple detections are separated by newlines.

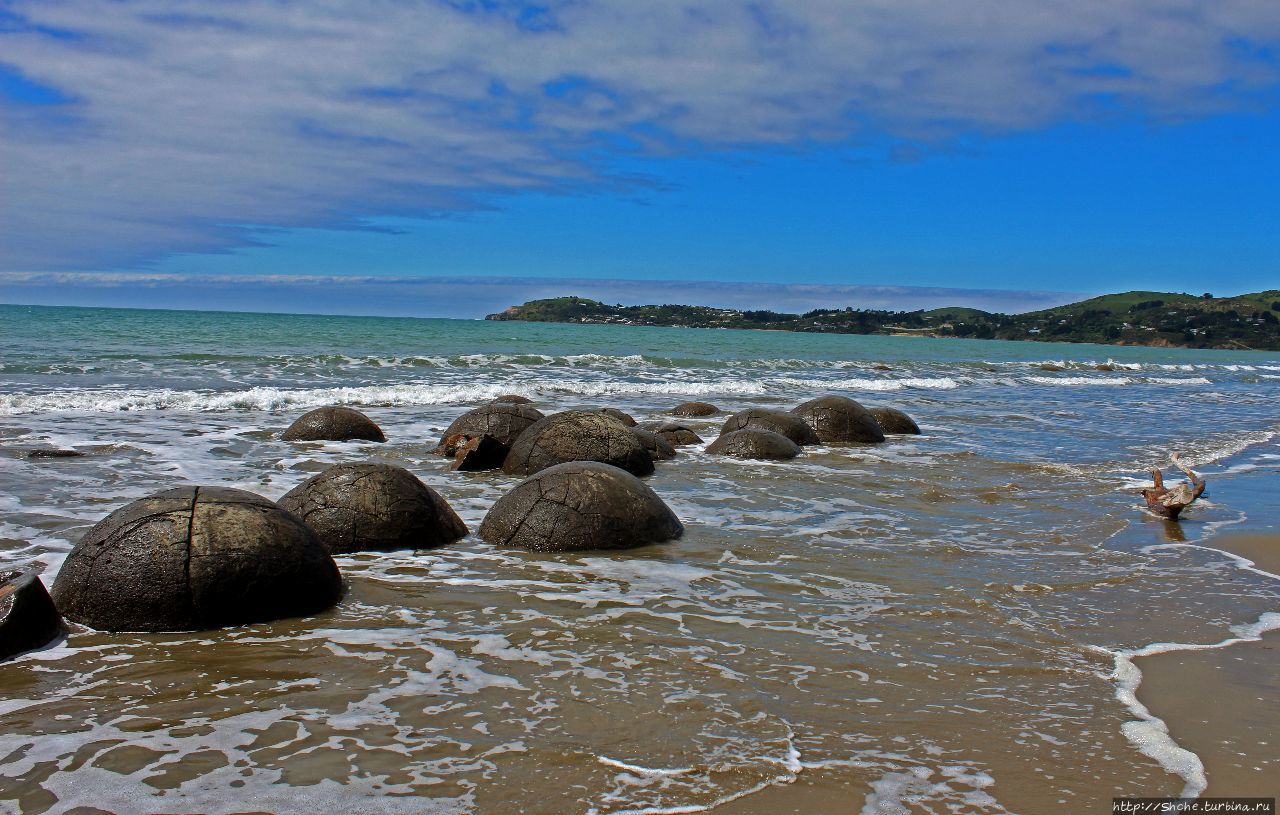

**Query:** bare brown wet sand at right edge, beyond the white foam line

left=1134, top=532, right=1280, bottom=797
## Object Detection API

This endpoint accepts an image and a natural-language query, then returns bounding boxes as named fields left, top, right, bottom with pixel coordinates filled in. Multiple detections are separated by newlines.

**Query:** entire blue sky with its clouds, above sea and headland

left=0, top=0, right=1280, bottom=316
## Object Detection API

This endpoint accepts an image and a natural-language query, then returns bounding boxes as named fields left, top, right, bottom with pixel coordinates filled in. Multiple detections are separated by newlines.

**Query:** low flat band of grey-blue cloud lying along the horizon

left=0, top=273, right=1087, bottom=319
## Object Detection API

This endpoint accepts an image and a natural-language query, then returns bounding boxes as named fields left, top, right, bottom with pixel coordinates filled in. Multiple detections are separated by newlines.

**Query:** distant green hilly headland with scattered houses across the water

left=485, top=289, right=1280, bottom=351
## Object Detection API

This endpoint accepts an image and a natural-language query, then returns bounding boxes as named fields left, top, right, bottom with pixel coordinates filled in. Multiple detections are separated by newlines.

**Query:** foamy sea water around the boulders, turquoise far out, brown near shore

left=0, top=306, right=1280, bottom=815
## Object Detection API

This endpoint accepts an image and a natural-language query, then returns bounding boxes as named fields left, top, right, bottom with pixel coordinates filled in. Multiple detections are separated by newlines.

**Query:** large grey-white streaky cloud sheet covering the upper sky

left=0, top=0, right=1280, bottom=270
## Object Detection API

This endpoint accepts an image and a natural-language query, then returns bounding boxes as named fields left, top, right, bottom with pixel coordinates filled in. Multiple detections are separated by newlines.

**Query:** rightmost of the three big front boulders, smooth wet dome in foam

left=480, top=462, right=685, bottom=551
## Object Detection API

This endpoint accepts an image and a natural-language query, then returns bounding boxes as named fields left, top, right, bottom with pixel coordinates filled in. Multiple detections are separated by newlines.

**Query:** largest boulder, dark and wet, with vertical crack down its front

left=52, top=486, right=342, bottom=631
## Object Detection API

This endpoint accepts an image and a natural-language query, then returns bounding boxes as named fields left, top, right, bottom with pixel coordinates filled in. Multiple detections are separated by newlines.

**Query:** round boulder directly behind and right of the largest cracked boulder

left=279, top=462, right=467, bottom=554
